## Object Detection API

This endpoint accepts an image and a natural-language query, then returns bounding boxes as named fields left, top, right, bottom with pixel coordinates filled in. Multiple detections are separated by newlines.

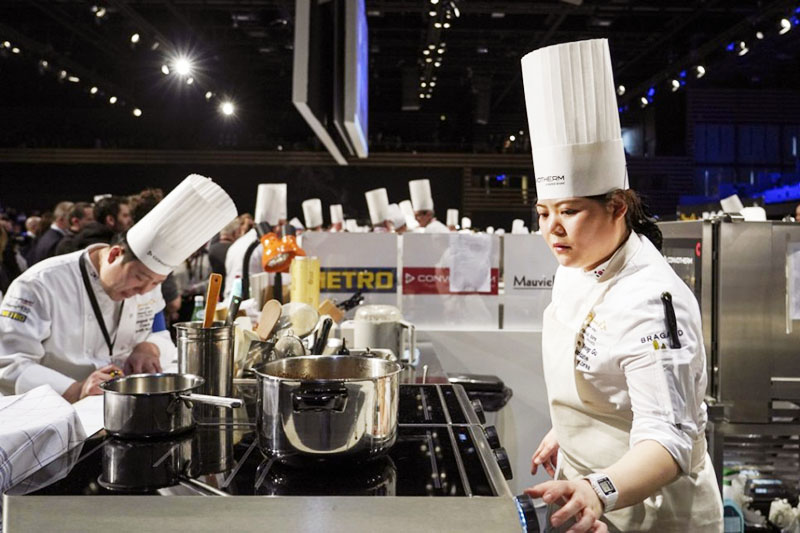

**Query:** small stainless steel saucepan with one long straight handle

left=100, top=374, right=242, bottom=438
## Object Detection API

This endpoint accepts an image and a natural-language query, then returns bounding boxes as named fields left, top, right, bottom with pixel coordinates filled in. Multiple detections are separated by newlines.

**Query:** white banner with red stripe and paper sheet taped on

left=402, top=233, right=500, bottom=329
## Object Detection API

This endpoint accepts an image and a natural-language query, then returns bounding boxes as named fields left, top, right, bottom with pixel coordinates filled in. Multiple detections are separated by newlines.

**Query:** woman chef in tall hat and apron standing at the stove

left=522, top=39, right=722, bottom=533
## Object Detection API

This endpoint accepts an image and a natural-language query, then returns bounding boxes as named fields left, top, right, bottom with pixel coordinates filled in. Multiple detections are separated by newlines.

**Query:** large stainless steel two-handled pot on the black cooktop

left=255, top=355, right=401, bottom=465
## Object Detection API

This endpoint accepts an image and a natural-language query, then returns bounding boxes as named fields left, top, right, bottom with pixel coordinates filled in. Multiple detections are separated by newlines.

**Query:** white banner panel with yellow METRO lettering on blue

left=302, top=231, right=398, bottom=305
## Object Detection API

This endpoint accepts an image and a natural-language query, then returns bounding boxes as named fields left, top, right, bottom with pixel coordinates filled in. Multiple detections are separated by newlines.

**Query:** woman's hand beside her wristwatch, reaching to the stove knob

left=525, top=479, right=608, bottom=533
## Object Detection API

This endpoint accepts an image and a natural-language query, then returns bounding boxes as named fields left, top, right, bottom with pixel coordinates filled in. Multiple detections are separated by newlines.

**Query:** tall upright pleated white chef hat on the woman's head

left=522, top=39, right=628, bottom=200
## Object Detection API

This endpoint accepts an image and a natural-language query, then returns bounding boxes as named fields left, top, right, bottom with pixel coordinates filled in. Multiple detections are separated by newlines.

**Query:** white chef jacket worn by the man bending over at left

left=0, top=244, right=176, bottom=394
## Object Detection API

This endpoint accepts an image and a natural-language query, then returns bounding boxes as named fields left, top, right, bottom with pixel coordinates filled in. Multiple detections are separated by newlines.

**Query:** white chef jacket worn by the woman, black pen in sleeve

left=550, top=232, right=707, bottom=473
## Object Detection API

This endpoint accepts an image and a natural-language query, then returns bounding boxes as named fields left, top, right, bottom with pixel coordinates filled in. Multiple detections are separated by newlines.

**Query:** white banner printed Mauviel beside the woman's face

left=502, top=235, right=558, bottom=331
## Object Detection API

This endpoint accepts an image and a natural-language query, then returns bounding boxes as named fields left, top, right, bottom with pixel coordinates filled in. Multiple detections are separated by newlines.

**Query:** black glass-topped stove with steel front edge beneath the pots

left=3, top=383, right=539, bottom=533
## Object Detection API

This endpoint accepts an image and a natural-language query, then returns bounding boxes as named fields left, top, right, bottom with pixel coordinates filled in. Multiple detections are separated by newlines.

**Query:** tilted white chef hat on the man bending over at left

left=127, top=174, right=237, bottom=276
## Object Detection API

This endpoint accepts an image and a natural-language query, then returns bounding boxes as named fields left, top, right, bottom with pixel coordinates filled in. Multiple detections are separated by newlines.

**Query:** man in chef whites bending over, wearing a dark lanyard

left=0, top=174, right=236, bottom=402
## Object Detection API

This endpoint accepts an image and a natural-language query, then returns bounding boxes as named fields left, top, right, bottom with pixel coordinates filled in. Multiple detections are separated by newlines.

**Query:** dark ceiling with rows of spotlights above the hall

left=0, top=0, right=800, bottom=152
